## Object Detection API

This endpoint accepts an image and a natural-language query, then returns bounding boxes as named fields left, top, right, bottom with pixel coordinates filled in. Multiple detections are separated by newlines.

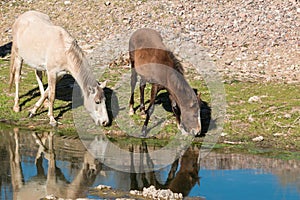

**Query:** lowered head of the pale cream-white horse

left=84, top=81, right=109, bottom=126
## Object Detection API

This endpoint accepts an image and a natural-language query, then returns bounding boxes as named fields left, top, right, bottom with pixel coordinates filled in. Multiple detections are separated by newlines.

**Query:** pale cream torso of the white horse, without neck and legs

left=12, top=11, right=74, bottom=70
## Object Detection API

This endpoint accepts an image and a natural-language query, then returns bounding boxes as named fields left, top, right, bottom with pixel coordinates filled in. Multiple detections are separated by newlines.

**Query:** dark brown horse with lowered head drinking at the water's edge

left=129, top=28, right=201, bottom=136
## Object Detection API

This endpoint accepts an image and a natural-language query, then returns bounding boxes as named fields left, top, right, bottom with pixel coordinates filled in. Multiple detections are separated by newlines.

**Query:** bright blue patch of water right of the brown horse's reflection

left=196, top=169, right=300, bottom=200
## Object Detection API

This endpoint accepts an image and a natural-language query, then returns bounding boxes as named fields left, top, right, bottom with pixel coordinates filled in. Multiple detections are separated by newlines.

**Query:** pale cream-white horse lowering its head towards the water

left=10, top=11, right=109, bottom=126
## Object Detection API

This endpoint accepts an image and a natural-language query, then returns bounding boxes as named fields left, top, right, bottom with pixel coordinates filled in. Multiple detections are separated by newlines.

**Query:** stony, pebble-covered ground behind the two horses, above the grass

left=0, top=0, right=300, bottom=83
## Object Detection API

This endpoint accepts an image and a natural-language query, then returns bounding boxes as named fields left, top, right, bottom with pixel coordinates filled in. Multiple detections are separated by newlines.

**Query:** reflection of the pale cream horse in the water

left=9, top=128, right=100, bottom=199
